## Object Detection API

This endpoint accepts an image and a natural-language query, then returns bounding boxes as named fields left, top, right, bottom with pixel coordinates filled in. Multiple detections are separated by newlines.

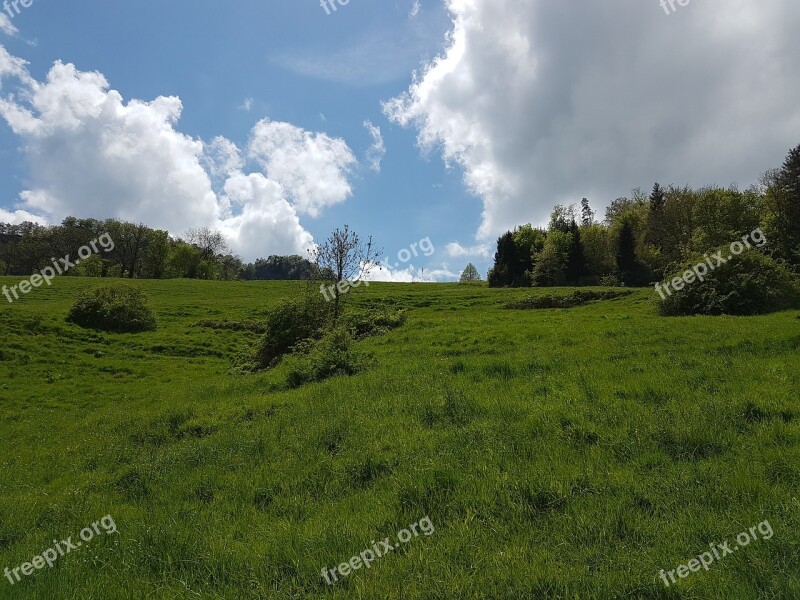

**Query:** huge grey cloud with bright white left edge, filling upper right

left=384, top=0, right=800, bottom=240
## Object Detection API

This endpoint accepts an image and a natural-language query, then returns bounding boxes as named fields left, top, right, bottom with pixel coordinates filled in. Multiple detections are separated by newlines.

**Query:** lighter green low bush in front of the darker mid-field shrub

left=286, top=327, right=369, bottom=388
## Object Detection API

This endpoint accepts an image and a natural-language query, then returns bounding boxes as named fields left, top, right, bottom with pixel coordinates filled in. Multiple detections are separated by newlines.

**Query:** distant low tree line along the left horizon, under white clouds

left=0, top=217, right=317, bottom=281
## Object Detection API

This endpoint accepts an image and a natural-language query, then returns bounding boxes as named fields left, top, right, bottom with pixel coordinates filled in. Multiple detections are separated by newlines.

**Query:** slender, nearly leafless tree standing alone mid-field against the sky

left=308, top=225, right=383, bottom=320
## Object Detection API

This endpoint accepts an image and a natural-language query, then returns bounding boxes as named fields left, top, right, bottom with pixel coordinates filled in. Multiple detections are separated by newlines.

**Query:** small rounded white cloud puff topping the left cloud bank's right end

left=248, top=119, right=358, bottom=217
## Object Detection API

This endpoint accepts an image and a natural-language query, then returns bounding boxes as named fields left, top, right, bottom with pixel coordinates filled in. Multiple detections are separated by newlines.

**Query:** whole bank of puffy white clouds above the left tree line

left=0, top=46, right=355, bottom=260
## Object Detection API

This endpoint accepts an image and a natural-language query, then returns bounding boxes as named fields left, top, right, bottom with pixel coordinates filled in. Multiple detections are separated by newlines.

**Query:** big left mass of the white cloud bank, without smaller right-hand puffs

left=0, top=62, right=219, bottom=230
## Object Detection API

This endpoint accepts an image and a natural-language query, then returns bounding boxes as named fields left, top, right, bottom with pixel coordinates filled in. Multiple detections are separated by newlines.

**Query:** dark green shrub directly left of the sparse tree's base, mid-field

left=256, top=295, right=331, bottom=368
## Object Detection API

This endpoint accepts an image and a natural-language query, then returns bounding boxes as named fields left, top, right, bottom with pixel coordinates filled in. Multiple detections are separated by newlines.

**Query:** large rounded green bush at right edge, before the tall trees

left=659, top=247, right=800, bottom=316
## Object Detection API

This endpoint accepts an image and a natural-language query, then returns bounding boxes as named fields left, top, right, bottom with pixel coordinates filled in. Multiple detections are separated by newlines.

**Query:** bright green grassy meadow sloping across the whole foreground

left=0, top=278, right=800, bottom=600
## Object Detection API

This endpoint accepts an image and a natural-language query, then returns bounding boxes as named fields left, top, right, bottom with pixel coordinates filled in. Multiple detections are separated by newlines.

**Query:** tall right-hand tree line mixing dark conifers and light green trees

left=488, top=146, right=800, bottom=287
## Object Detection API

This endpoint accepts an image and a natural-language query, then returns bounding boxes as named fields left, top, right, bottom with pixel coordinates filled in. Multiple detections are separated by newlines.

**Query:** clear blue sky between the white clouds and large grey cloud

left=0, top=0, right=480, bottom=280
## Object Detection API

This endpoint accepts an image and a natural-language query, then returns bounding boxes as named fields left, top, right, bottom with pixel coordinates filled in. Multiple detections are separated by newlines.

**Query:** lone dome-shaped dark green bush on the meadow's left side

left=67, top=284, right=156, bottom=333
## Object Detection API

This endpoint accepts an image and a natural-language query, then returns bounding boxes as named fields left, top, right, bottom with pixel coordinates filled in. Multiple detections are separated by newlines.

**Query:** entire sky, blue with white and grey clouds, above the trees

left=0, top=0, right=800, bottom=281
